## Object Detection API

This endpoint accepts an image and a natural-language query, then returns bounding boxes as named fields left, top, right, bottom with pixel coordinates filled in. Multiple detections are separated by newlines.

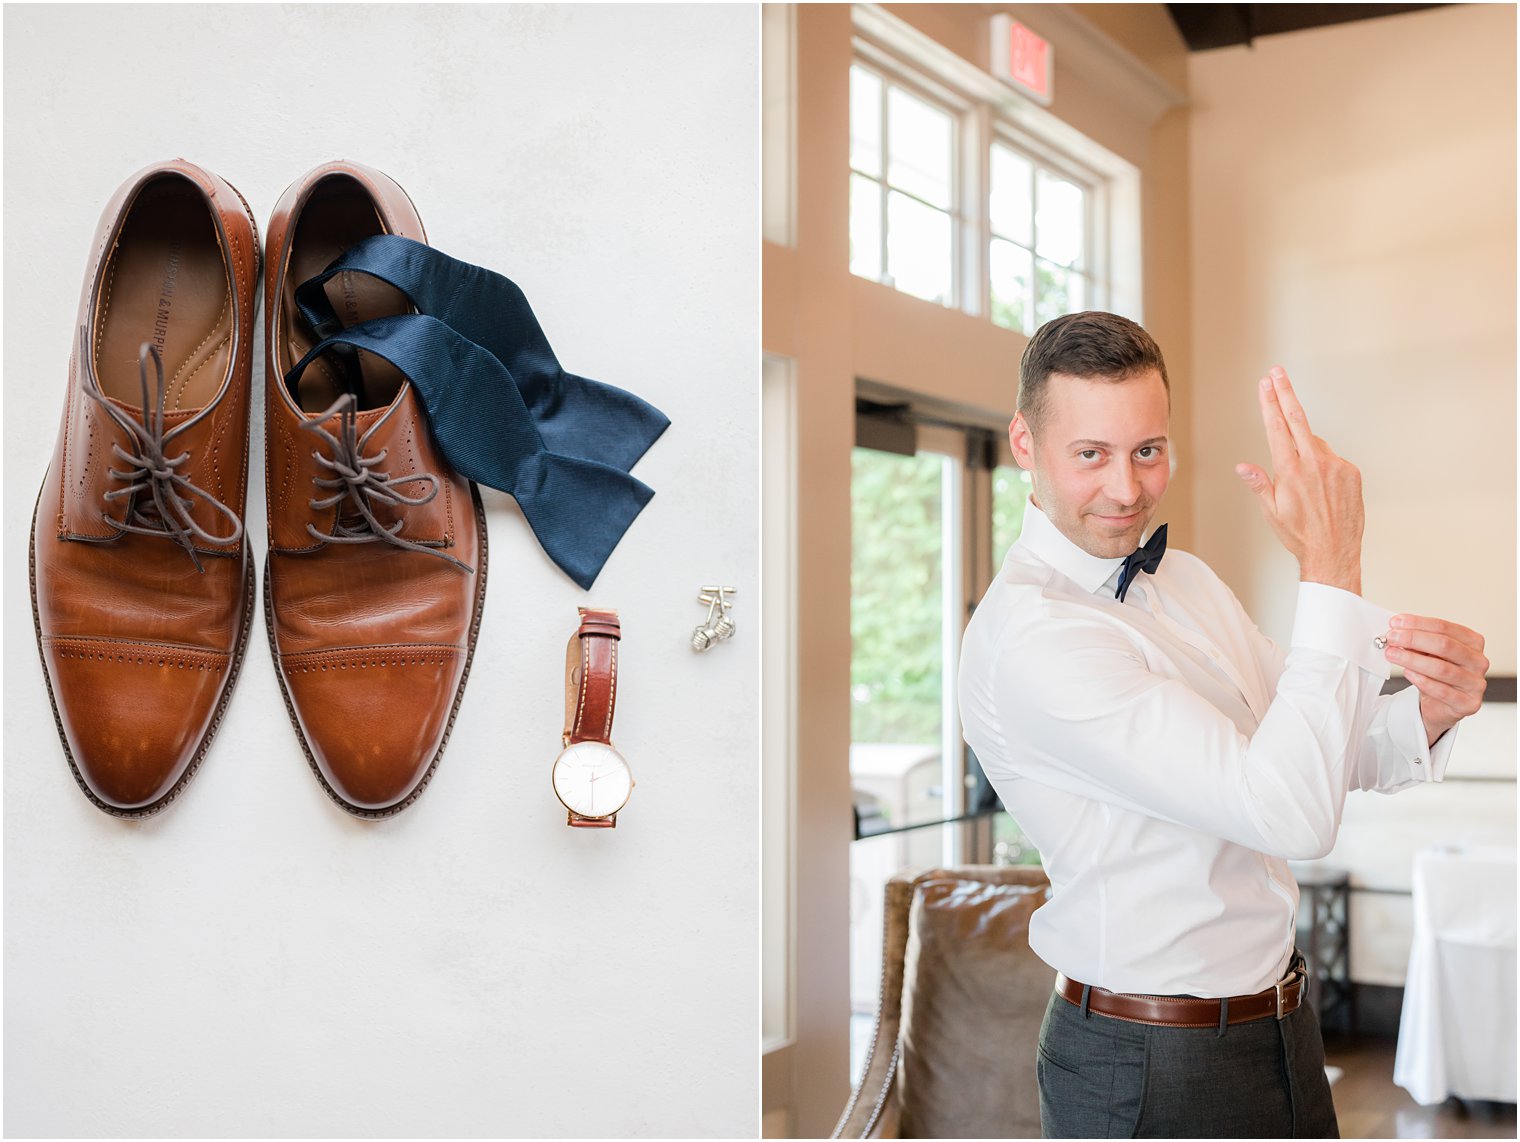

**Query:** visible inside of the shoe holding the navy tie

left=281, top=183, right=412, bottom=412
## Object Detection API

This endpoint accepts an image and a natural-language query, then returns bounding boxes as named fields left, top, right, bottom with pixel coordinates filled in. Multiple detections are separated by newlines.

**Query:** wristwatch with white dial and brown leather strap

left=550, top=607, right=634, bottom=829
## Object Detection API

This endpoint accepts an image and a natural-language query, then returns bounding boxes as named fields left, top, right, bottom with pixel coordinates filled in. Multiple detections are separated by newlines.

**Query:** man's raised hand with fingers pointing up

left=1236, top=365, right=1362, bottom=595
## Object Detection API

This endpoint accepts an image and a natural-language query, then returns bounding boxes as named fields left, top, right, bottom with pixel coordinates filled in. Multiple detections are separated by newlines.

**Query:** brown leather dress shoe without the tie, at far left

left=30, top=160, right=258, bottom=817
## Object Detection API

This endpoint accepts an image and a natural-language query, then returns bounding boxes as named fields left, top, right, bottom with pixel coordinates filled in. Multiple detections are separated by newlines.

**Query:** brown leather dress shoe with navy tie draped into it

left=264, top=163, right=486, bottom=818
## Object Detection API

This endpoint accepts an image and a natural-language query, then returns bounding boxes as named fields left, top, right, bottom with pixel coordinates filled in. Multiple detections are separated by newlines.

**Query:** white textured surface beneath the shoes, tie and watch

left=5, top=6, right=758, bottom=1136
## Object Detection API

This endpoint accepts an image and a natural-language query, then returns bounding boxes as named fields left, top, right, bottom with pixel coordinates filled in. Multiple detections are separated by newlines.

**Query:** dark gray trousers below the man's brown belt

left=1038, top=993, right=1341, bottom=1137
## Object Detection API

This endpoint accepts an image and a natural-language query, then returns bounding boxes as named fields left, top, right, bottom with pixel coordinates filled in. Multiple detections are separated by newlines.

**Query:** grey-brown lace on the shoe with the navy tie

left=301, top=392, right=474, bottom=575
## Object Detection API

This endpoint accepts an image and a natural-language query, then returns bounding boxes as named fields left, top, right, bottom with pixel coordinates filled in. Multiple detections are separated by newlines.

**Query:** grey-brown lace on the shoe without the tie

left=81, top=328, right=243, bottom=573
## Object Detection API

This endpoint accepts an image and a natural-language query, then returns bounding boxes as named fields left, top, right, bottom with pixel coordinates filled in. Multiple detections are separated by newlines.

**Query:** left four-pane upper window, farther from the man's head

left=850, top=64, right=956, bottom=306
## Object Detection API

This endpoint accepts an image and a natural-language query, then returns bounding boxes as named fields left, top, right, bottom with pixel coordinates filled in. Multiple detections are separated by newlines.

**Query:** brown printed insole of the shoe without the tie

left=94, top=175, right=233, bottom=412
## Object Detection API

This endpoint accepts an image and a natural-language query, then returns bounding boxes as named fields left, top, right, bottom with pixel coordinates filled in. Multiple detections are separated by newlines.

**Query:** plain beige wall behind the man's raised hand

left=1189, top=5, right=1515, bottom=659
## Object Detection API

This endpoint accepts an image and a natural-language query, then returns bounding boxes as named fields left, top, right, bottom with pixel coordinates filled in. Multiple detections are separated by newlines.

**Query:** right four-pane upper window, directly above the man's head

left=986, top=141, right=1097, bottom=336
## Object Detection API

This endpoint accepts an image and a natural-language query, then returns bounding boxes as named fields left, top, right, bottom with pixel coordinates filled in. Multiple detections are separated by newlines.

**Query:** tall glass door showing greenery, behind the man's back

left=850, top=404, right=1038, bottom=1078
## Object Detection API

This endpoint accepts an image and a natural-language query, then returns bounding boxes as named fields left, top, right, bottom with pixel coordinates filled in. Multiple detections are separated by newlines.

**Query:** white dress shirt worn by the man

left=959, top=503, right=1455, bottom=998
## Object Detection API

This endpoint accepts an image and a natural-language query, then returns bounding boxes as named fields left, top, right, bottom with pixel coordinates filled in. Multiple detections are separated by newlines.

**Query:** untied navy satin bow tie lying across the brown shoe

left=284, top=234, right=670, bottom=590
